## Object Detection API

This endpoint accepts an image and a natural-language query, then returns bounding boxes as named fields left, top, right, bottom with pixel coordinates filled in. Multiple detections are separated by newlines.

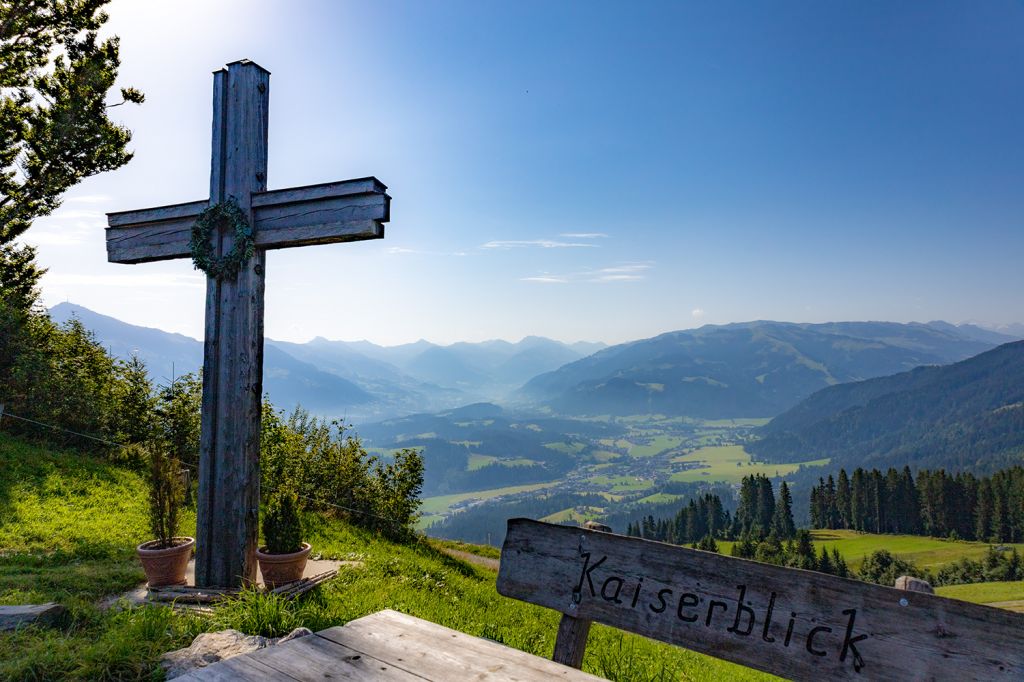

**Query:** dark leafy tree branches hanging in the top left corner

left=0, top=0, right=143, bottom=309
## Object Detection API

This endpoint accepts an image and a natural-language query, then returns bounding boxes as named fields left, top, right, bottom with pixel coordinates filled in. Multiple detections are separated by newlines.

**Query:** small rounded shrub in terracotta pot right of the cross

left=256, top=491, right=310, bottom=590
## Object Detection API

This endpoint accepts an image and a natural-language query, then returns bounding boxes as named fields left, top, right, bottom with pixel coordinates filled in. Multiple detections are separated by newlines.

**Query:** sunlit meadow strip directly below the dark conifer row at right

left=811, top=530, right=1024, bottom=570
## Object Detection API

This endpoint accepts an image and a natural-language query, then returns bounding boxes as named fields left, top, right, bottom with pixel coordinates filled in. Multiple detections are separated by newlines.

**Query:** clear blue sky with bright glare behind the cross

left=27, top=0, right=1024, bottom=344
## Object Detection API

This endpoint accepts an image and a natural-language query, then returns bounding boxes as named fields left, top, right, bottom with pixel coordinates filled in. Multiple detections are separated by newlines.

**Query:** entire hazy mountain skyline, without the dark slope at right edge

left=50, top=303, right=1014, bottom=423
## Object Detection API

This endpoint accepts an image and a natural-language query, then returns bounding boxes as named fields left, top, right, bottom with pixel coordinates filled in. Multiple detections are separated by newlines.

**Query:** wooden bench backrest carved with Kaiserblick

left=498, top=518, right=1024, bottom=680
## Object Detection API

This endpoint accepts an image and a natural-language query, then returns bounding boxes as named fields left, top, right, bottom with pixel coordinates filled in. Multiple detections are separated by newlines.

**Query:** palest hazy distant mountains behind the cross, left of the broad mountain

left=49, top=303, right=605, bottom=421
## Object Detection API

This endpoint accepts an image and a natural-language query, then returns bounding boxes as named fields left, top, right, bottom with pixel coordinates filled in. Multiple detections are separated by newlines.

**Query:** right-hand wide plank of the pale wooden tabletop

left=317, top=610, right=600, bottom=682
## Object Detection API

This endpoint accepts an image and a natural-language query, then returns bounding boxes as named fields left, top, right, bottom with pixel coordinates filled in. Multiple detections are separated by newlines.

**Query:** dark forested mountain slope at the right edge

left=746, top=341, right=1024, bottom=472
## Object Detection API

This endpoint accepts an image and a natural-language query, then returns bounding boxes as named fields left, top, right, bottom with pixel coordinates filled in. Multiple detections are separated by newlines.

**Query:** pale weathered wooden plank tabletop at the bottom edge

left=177, top=610, right=601, bottom=682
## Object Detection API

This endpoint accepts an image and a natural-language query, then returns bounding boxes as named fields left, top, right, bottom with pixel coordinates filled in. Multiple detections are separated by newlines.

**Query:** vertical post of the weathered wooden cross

left=196, top=60, right=270, bottom=587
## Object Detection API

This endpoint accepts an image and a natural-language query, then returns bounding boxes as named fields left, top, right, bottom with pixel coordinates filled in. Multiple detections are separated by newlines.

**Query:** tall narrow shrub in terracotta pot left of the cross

left=136, top=443, right=196, bottom=587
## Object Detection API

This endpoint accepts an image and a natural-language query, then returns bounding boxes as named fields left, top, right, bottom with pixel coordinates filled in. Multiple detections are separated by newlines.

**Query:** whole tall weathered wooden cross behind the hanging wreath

left=106, top=59, right=390, bottom=588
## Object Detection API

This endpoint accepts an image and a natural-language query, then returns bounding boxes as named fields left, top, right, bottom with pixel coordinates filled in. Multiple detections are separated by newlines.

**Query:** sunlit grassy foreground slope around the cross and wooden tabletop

left=0, top=434, right=768, bottom=680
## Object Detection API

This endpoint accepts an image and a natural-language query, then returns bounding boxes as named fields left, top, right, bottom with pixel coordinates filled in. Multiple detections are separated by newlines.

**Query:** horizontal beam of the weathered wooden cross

left=106, top=177, right=391, bottom=263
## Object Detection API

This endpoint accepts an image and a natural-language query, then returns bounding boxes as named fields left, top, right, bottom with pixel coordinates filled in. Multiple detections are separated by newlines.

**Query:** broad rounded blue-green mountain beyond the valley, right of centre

left=518, top=322, right=1014, bottom=419
